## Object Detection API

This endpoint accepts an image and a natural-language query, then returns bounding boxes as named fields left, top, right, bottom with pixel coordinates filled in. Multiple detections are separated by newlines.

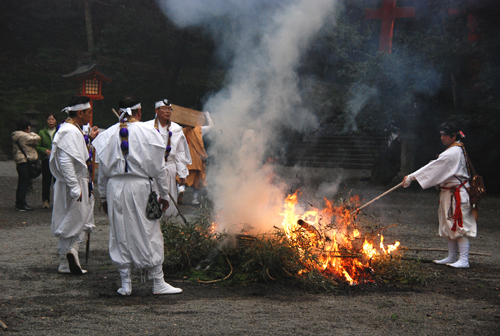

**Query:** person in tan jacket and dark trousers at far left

left=12, top=118, right=40, bottom=211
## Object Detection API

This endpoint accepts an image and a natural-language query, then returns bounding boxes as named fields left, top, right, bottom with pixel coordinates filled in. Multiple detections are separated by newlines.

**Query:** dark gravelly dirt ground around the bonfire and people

left=0, top=162, right=500, bottom=336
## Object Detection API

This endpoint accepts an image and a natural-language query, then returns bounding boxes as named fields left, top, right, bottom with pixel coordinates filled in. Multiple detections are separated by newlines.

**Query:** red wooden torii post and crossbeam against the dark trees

left=365, top=0, right=415, bottom=54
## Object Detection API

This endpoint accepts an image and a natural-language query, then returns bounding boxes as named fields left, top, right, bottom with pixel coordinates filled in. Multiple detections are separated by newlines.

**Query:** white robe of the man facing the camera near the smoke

left=146, top=119, right=191, bottom=217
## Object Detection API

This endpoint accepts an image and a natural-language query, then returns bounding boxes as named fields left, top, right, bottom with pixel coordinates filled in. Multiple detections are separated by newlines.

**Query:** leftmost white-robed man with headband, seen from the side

left=49, top=96, right=99, bottom=275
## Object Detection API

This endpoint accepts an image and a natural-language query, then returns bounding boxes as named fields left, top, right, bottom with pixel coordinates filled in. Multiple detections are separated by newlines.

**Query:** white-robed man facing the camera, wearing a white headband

left=146, top=99, right=192, bottom=217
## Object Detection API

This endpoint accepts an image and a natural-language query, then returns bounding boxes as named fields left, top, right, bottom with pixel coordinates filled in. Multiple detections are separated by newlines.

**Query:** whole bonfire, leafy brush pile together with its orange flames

left=163, top=192, right=414, bottom=290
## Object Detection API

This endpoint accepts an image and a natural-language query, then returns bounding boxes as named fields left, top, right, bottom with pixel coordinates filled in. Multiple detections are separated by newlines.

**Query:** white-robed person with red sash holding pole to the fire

left=403, top=122, right=477, bottom=268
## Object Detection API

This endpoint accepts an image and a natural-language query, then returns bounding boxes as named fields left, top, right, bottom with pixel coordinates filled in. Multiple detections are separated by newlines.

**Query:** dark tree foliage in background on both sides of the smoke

left=0, top=0, right=500, bottom=186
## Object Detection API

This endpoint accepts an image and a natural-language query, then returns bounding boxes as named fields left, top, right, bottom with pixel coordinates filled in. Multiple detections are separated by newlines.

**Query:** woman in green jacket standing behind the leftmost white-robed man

left=36, top=113, right=57, bottom=209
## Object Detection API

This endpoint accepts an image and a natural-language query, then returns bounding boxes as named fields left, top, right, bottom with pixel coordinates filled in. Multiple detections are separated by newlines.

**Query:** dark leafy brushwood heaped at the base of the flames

left=162, top=201, right=432, bottom=291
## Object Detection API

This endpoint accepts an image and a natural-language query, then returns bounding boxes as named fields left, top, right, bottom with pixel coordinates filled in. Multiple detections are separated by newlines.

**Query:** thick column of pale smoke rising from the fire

left=158, top=0, right=336, bottom=232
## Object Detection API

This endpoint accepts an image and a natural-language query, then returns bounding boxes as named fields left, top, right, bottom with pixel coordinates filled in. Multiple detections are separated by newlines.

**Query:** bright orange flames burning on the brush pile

left=280, top=191, right=399, bottom=285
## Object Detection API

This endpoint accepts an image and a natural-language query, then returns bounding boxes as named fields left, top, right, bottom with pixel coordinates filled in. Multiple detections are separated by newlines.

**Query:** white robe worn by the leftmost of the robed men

left=49, top=123, right=95, bottom=238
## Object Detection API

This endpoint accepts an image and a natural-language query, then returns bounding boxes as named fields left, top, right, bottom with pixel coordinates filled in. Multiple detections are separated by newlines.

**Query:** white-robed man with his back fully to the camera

left=93, top=96, right=182, bottom=295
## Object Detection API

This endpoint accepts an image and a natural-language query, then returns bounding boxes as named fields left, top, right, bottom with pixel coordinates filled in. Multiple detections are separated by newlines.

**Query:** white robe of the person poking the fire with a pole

left=411, top=142, right=477, bottom=239
